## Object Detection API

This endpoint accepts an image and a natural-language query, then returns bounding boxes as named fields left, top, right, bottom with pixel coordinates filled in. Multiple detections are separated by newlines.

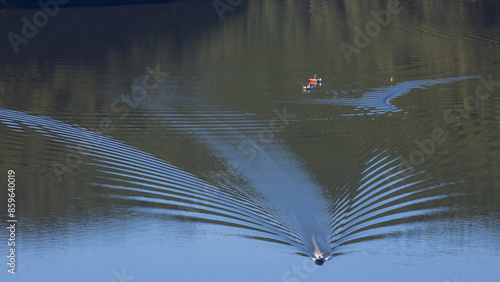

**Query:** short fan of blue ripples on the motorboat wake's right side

left=330, top=147, right=463, bottom=252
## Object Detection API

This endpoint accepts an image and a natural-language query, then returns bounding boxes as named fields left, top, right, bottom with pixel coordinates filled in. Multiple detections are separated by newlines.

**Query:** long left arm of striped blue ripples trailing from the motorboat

left=0, top=108, right=304, bottom=250
